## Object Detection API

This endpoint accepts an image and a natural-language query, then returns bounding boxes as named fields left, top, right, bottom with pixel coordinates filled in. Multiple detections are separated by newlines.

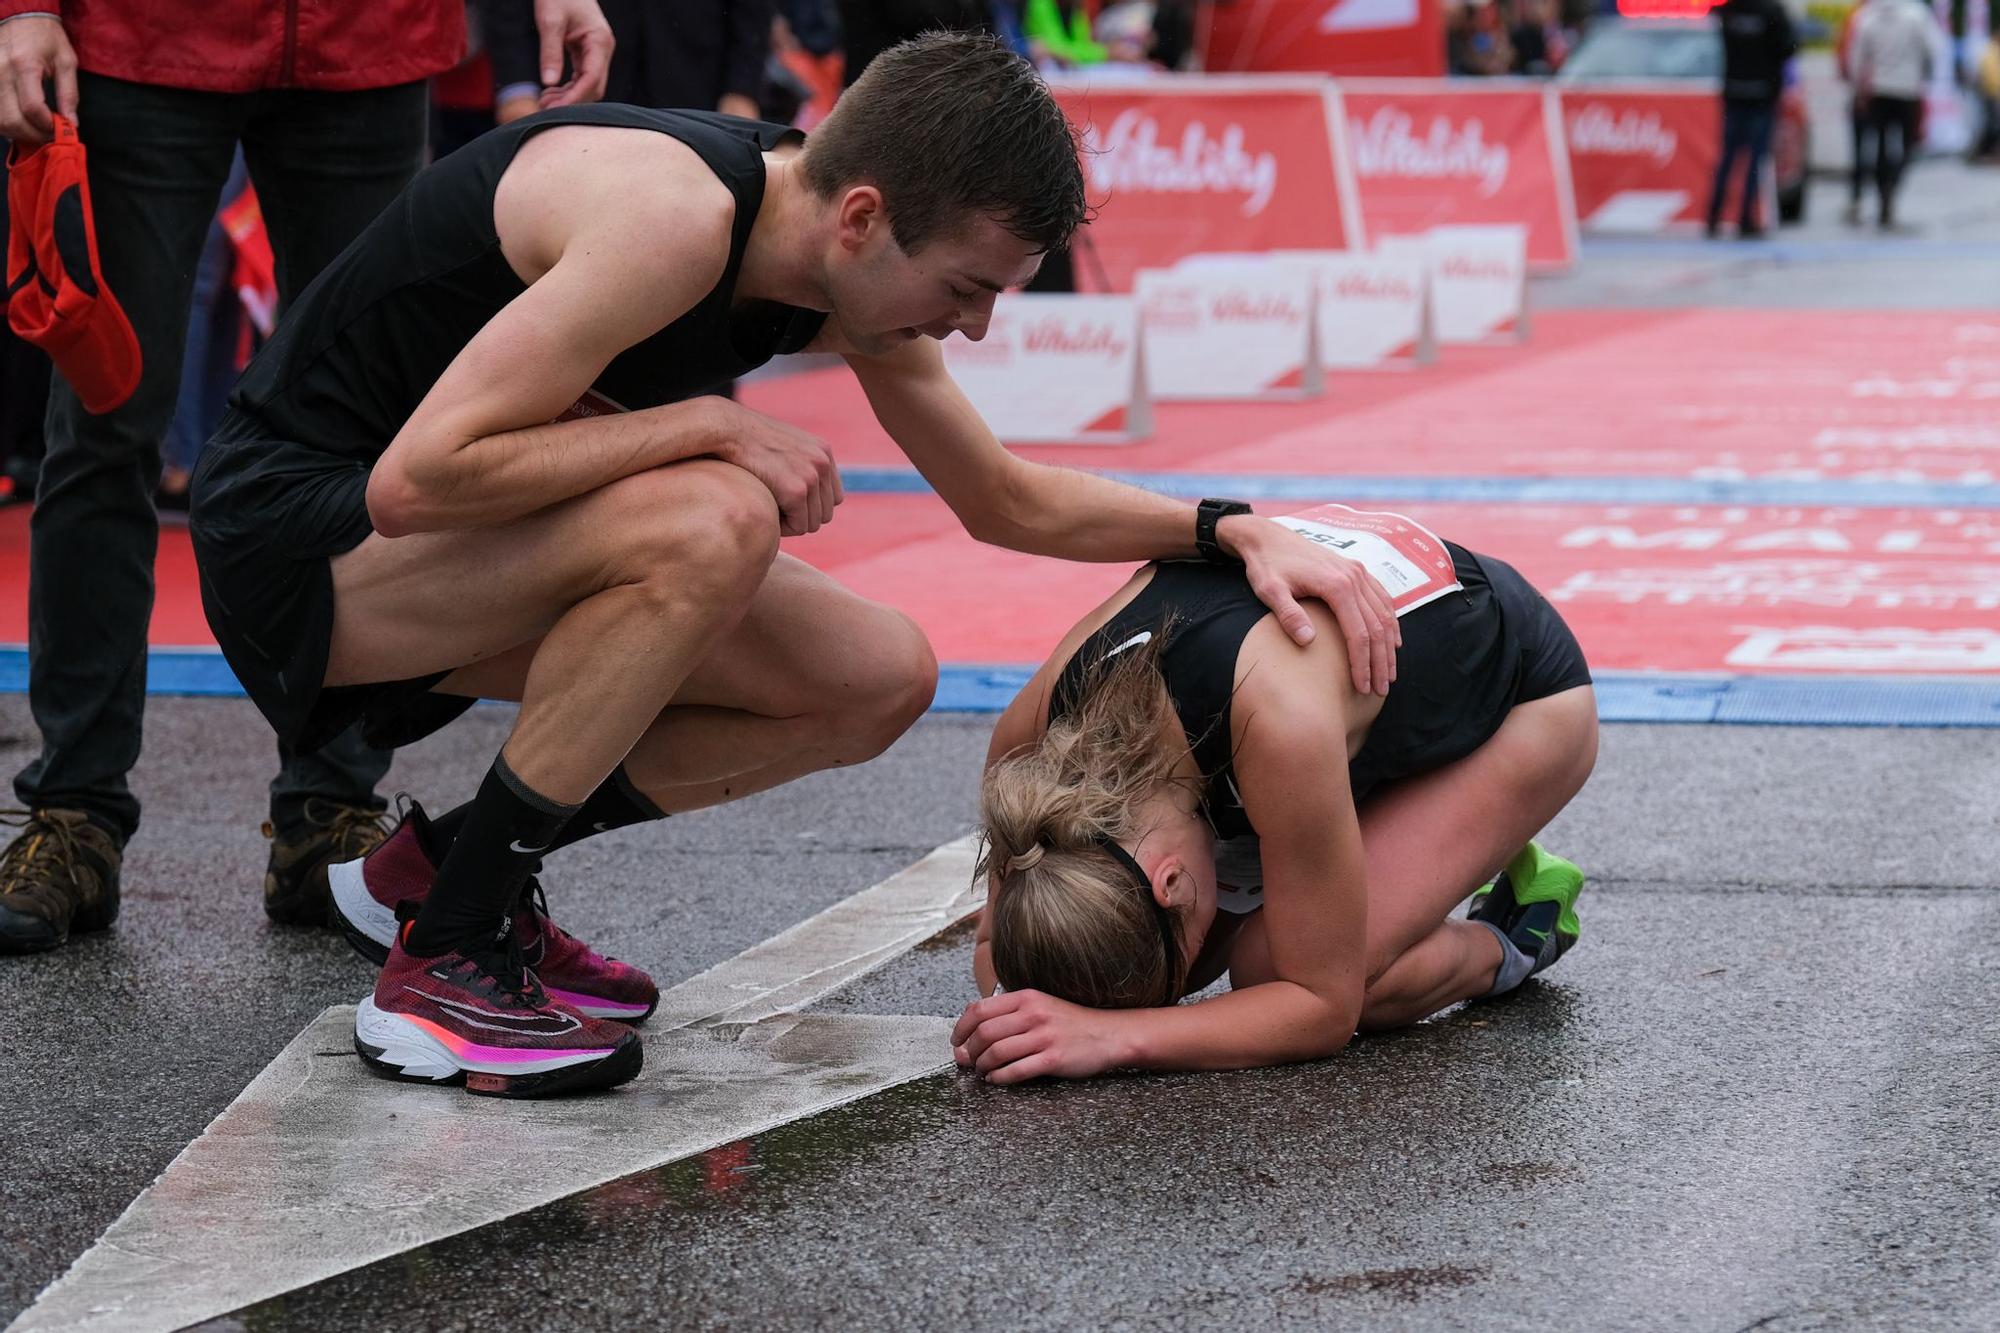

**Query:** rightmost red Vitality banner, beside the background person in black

left=1560, top=84, right=1720, bottom=232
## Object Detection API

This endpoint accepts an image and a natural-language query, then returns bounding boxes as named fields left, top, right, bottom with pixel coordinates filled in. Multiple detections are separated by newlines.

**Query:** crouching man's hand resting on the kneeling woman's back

left=1216, top=514, right=1402, bottom=695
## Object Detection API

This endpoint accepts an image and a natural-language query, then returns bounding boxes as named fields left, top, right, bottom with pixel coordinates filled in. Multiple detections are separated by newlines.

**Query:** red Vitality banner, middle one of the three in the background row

left=1340, top=78, right=1576, bottom=272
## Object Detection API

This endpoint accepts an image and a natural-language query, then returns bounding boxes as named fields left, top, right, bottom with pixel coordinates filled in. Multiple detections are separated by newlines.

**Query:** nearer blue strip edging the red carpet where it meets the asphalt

left=0, top=644, right=2000, bottom=727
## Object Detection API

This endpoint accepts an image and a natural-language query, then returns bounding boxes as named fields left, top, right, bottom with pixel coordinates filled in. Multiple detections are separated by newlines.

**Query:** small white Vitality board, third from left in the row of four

left=1278, top=250, right=1438, bottom=370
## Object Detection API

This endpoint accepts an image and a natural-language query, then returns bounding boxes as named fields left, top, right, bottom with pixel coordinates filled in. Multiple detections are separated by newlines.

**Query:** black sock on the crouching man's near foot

left=404, top=757, right=578, bottom=959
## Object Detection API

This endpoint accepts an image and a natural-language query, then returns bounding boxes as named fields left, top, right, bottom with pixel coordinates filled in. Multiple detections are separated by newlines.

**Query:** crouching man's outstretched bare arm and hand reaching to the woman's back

left=846, top=338, right=1402, bottom=695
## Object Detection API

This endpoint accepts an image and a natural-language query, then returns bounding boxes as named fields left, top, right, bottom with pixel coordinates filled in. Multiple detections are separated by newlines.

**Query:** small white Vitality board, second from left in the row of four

left=1138, top=256, right=1326, bottom=402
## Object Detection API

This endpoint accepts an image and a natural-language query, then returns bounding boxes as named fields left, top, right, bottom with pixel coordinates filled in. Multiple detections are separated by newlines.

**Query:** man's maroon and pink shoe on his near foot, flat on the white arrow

left=354, top=927, right=646, bottom=1097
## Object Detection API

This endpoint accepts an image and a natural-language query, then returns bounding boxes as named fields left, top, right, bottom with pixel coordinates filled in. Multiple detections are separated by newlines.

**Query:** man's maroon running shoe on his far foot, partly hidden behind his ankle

left=326, top=801, right=660, bottom=1023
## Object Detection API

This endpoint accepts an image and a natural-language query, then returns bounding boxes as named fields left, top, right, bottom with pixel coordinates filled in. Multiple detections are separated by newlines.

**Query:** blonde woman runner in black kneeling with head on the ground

left=952, top=504, right=1598, bottom=1083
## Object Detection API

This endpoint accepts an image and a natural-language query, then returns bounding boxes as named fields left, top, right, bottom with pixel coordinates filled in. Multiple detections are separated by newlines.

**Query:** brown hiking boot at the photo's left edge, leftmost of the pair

left=0, top=809, right=124, bottom=953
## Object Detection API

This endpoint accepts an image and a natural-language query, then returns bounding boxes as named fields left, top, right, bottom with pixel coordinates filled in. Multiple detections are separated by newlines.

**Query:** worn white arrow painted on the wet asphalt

left=8, top=835, right=984, bottom=1333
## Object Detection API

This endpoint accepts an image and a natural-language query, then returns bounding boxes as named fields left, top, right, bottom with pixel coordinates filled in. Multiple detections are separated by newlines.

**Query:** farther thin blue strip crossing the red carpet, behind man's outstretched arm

left=840, top=468, right=2000, bottom=508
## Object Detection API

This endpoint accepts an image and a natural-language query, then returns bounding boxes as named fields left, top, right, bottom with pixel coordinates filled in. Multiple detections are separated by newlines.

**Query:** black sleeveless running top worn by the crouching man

left=202, top=104, right=826, bottom=552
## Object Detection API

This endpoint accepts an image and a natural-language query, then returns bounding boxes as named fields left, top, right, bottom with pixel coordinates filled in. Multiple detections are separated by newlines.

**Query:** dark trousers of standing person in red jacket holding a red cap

left=14, top=74, right=428, bottom=837
